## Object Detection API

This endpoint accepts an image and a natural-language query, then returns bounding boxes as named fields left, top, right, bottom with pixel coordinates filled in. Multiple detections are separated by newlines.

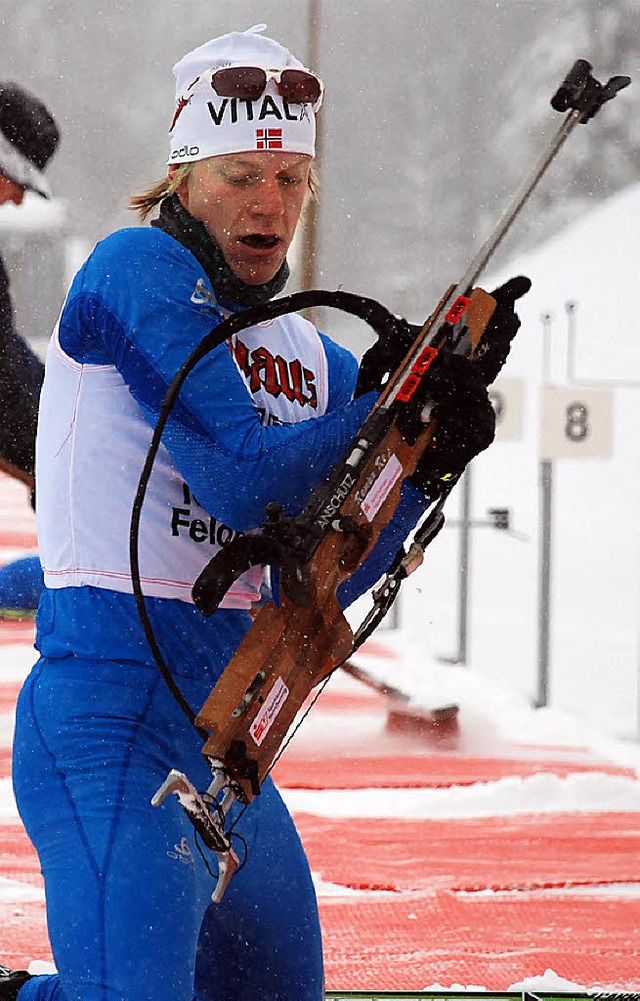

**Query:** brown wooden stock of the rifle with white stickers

left=196, top=288, right=495, bottom=802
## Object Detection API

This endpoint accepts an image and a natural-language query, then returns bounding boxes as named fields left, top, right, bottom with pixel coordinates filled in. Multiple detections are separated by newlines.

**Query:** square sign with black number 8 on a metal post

left=541, top=386, right=613, bottom=461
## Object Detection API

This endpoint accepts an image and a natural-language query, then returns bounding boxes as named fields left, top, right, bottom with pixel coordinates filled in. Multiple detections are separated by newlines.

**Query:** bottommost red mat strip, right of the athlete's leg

left=321, top=892, right=640, bottom=990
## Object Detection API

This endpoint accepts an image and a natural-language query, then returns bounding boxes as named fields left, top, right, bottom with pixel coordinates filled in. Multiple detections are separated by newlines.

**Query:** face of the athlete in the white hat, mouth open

left=177, top=151, right=311, bottom=285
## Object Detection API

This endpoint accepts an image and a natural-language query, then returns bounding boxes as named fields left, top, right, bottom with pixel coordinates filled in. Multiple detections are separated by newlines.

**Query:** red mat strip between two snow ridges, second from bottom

left=295, top=813, right=640, bottom=892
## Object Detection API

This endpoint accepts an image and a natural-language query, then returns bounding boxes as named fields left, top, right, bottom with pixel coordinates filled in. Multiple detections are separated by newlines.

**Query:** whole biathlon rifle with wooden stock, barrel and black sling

left=141, top=60, right=630, bottom=901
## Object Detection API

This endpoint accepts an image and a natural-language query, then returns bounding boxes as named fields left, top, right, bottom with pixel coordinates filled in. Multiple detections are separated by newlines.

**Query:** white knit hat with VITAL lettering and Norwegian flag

left=168, top=24, right=315, bottom=163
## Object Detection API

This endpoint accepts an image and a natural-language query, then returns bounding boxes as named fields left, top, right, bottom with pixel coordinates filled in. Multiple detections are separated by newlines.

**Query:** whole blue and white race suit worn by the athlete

left=14, top=228, right=426, bottom=1001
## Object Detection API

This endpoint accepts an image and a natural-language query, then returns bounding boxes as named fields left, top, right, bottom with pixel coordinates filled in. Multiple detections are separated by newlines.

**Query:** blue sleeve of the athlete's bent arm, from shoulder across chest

left=60, top=229, right=376, bottom=531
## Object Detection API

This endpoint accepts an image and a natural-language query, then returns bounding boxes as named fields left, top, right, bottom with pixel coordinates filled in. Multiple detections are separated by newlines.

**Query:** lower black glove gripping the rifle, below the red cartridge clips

left=411, top=354, right=496, bottom=499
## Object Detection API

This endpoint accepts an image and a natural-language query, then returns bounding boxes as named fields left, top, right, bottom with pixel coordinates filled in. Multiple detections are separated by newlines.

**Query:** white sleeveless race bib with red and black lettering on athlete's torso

left=36, top=315, right=328, bottom=609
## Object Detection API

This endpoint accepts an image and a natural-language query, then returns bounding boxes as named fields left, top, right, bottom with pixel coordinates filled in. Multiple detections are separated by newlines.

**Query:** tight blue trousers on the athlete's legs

left=13, top=658, right=323, bottom=1001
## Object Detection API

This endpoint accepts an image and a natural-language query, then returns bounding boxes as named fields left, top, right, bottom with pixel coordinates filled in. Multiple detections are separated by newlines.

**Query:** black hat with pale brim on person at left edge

left=0, top=83, right=60, bottom=198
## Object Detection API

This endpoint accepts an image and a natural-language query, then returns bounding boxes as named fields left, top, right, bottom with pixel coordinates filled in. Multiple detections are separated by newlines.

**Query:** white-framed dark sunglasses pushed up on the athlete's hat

left=190, top=66, right=325, bottom=111
